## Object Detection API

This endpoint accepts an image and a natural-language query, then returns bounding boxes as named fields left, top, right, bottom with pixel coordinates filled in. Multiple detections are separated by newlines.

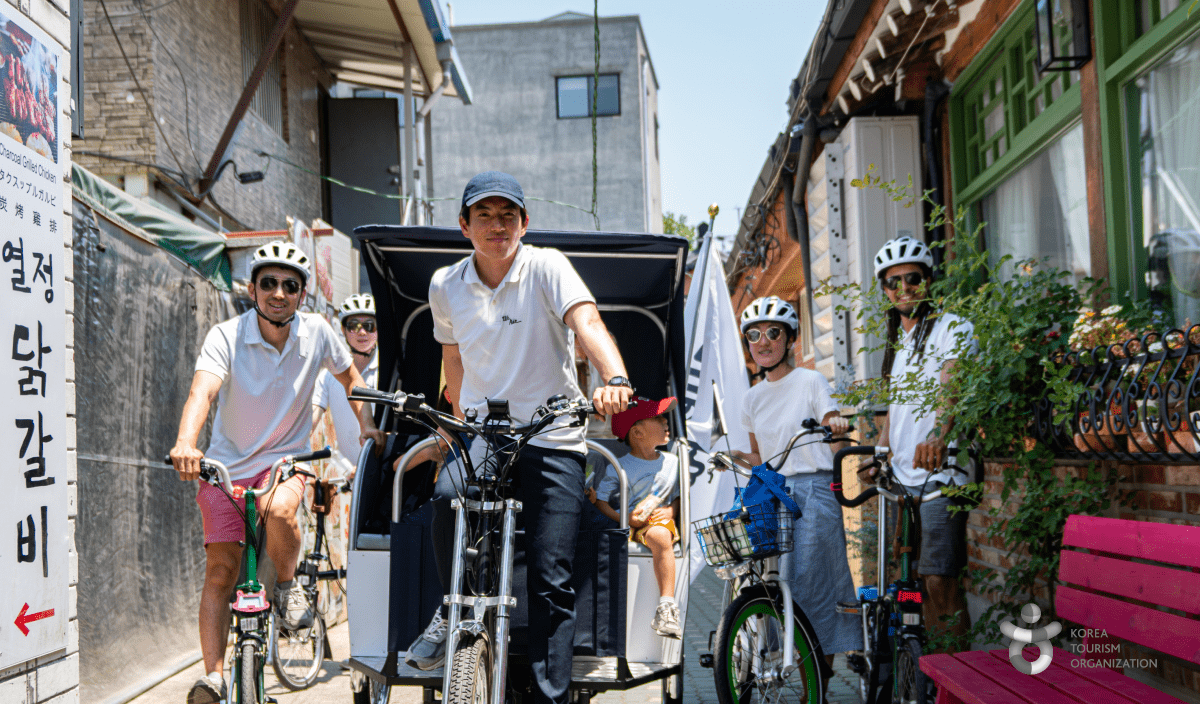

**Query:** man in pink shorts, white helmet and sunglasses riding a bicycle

left=170, top=241, right=383, bottom=704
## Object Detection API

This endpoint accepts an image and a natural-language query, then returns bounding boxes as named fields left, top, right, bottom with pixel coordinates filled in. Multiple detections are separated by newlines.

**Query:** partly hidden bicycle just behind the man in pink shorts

left=268, top=470, right=350, bottom=691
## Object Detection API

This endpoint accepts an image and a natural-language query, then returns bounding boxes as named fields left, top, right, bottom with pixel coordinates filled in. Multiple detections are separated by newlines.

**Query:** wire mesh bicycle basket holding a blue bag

left=691, top=503, right=792, bottom=566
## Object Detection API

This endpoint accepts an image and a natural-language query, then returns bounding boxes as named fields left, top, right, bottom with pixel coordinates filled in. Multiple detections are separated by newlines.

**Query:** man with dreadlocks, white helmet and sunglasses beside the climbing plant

left=863, top=237, right=974, bottom=652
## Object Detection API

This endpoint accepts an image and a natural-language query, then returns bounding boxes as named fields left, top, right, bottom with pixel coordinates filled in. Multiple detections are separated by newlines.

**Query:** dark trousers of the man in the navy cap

left=433, top=446, right=584, bottom=704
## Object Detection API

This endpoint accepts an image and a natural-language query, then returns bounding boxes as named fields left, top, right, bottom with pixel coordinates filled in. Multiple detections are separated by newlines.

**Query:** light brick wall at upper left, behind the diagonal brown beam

left=79, top=0, right=329, bottom=229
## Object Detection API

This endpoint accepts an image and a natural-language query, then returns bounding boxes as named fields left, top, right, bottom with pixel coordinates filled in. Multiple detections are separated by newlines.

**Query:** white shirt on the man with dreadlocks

left=888, top=313, right=978, bottom=486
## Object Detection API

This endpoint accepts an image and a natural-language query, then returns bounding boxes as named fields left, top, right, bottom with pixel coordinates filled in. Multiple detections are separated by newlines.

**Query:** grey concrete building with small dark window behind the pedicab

left=431, top=17, right=662, bottom=233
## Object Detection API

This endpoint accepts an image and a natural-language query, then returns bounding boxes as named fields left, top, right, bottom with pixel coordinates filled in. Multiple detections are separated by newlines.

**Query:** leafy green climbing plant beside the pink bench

left=830, top=173, right=1118, bottom=643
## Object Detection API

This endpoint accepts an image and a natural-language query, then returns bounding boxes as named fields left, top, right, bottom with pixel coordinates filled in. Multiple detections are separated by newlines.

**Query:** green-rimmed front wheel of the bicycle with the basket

left=713, top=586, right=824, bottom=704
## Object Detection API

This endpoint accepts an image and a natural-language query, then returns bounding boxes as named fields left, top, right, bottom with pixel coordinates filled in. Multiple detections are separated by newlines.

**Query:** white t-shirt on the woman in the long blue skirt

left=742, top=367, right=839, bottom=476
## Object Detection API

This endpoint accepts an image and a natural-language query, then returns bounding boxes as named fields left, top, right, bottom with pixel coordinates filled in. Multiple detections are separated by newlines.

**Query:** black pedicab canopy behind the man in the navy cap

left=354, top=225, right=688, bottom=433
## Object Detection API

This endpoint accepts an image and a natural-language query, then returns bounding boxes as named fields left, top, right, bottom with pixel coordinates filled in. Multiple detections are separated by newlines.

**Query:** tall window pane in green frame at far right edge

left=1133, top=38, right=1200, bottom=325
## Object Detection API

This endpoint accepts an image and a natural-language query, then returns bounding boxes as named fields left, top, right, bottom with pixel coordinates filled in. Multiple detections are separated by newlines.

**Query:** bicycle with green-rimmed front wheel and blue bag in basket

left=692, top=419, right=845, bottom=704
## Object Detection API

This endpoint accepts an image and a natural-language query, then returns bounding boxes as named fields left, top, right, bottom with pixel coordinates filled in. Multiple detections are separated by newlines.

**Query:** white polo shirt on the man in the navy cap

left=430, top=245, right=595, bottom=452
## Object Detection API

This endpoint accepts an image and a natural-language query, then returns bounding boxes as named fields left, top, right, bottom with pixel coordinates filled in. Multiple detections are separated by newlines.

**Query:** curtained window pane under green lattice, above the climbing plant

left=982, top=125, right=1092, bottom=281
